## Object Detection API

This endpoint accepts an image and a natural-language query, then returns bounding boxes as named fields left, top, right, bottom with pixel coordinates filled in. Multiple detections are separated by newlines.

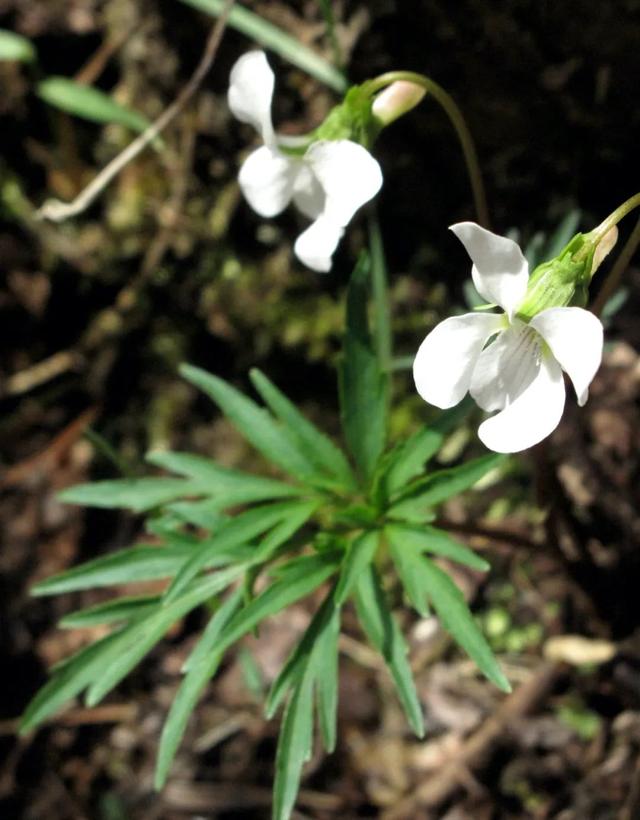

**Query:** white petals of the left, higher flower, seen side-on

left=228, top=51, right=382, bottom=272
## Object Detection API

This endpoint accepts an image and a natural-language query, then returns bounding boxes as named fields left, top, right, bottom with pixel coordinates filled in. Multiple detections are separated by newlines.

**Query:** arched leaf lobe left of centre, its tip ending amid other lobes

left=164, top=501, right=306, bottom=603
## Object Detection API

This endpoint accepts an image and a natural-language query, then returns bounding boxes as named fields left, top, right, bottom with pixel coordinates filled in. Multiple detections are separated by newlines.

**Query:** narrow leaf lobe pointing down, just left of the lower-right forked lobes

left=356, top=566, right=424, bottom=737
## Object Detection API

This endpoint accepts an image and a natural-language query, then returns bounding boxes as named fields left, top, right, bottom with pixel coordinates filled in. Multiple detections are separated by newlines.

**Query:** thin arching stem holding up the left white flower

left=366, top=71, right=489, bottom=228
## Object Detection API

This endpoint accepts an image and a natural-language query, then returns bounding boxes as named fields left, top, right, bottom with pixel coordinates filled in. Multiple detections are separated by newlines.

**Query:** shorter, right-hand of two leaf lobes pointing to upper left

left=250, top=369, right=356, bottom=489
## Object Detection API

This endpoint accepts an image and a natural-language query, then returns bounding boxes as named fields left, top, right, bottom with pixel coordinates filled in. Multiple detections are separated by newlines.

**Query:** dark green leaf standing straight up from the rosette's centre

left=339, top=255, right=388, bottom=480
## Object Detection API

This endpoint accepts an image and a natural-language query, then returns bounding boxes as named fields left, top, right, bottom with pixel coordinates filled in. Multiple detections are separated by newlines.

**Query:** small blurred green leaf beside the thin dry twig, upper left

left=37, top=77, right=151, bottom=133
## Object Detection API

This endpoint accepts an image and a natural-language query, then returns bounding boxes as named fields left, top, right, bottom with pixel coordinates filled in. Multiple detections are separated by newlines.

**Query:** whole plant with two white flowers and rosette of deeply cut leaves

left=22, top=22, right=640, bottom=820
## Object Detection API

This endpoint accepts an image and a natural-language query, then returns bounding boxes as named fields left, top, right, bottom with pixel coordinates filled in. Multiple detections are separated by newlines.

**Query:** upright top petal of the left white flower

left=227, top=51, right=275, bottom=145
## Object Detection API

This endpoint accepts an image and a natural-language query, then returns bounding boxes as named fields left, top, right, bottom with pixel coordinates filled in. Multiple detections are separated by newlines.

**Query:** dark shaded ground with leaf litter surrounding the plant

left=0, top=0, right=640, bottom=820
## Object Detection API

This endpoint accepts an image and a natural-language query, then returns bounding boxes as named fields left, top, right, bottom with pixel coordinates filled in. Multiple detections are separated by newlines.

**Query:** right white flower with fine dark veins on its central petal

left=413, top=222, right=603, bottom=453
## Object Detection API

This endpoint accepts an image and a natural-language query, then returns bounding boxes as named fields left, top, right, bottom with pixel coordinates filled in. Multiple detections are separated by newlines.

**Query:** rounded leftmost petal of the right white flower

left=413, top=313, right=503, bottom=409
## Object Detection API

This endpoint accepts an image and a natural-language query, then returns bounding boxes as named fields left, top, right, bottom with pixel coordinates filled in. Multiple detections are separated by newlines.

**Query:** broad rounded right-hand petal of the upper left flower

left=305, top=140, right=382, bottom=228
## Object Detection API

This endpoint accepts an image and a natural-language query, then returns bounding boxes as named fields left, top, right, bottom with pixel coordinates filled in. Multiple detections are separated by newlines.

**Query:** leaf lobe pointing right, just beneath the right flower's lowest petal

left=389, top=453, right=505, bottom=520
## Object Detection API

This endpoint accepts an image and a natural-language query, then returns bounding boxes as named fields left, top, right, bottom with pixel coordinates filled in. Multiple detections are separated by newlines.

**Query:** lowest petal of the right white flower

left=478, top=354, right=565, bottom=453
